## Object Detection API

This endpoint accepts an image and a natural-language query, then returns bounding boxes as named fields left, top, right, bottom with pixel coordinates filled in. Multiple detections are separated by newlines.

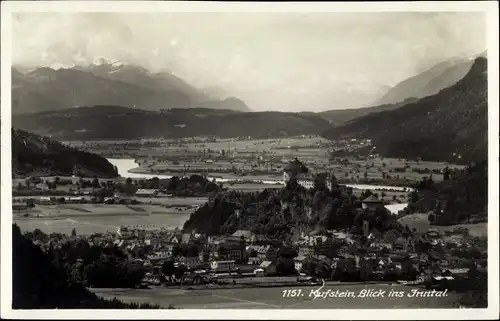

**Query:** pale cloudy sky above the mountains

left=12, top=12, right=486, bottom=112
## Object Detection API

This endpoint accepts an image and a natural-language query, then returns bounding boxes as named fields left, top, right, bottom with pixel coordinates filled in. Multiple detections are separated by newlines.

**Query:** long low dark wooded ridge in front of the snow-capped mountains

left=12, top=106, right=330, bottom=140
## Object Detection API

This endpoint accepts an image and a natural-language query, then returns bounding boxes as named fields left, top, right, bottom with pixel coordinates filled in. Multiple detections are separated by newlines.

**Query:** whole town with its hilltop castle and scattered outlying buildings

left=18, top=159, right=487, bottom=296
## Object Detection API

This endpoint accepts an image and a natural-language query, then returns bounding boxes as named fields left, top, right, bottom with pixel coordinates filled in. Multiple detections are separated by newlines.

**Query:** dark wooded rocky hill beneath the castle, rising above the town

left=183, top=176, right=402, bottom=241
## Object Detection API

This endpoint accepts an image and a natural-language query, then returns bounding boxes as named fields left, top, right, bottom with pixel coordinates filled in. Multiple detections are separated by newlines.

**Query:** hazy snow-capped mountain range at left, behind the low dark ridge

left=12, top=61, right=254, bottom=114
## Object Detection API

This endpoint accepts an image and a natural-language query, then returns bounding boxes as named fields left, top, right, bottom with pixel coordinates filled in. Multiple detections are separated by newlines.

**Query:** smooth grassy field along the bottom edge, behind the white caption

left=91, top=284, right=456, bottom=309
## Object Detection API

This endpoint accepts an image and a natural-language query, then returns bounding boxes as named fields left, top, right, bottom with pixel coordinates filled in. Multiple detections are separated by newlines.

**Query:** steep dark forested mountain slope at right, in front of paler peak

left=323, top=57, right=488, bottom=163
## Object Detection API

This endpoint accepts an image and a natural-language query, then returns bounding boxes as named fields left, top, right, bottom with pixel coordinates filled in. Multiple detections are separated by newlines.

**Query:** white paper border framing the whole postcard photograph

left=0, top=1, right=499, bottom=320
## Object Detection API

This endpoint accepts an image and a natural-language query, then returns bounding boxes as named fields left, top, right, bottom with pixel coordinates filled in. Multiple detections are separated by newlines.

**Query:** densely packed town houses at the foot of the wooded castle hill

left=82, top=221, right=486, bottom=282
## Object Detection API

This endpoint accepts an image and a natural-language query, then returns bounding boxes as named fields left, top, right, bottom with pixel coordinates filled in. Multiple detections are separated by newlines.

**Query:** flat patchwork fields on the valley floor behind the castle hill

left=65, top=136, right=457, bottom=185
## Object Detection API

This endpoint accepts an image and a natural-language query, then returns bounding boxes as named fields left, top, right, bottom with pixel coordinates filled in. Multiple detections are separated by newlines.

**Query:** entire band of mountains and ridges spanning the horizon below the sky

left=12, top=53, right=487, bottom=162
